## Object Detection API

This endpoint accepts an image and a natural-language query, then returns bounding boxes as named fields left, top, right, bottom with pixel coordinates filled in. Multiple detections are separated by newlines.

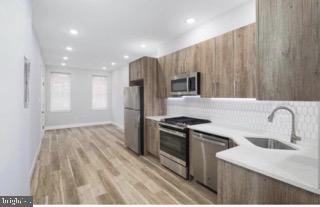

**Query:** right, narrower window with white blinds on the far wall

left=92, top=75, right=108, bottom=110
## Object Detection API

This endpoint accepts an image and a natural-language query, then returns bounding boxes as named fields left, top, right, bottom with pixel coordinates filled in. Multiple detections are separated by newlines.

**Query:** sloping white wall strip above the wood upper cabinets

left=157, top=0, right=256, bottom=57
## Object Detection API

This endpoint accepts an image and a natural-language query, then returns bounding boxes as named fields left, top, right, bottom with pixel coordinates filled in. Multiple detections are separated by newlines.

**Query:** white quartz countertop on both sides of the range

left=146, top=115, right=320, bottom=194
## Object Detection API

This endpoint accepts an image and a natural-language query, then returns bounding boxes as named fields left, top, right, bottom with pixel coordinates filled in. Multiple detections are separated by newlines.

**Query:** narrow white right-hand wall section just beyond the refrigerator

left=111, top=66, right=129, bottom=129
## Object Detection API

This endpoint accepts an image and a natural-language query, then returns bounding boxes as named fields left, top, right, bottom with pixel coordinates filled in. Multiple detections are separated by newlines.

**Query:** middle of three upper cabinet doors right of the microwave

left=212, top=32, right=234, bottom=98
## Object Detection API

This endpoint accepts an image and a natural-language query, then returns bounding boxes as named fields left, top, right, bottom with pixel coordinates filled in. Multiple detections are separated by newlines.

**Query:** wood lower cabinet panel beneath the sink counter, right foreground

left=218, top=159, right=320, bottom=204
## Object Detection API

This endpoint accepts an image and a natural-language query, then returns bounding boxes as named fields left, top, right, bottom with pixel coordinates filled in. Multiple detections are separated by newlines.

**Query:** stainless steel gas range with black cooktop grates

left=160, top=116, right=210, bottom=179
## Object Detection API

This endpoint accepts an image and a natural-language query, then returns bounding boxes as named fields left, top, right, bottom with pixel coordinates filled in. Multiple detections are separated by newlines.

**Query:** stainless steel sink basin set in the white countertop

left=246, top=137, right=296, bottom=150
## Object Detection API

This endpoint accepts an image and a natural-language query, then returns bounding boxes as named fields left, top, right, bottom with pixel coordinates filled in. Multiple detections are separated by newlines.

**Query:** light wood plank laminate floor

left=31, top=125, right=216, bottom=204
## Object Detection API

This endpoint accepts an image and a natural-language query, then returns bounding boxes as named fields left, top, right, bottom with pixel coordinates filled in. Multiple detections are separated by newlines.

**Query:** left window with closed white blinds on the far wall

left=50, top=73, right=71, bottom=112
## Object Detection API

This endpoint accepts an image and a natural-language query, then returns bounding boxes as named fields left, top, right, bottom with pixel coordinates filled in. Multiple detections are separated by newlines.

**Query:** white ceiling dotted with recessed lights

left=33, top=0, right=248, bottom=69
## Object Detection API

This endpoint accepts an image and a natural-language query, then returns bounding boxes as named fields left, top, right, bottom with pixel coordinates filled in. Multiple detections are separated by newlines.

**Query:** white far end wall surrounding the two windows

left=46, top=66, right=112, bottom=129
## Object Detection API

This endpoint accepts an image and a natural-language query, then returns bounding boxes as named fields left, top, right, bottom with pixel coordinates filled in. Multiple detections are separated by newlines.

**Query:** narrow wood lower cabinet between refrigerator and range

left=144, top=119, right=160, bottom=158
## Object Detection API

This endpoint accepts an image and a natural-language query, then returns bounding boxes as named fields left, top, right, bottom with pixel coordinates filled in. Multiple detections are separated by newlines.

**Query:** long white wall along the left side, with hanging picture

left=0, top=0, right=44, bottom=195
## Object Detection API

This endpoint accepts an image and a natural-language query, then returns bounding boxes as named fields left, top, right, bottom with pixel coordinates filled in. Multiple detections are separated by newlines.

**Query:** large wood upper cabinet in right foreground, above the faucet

left=257, top=0, right=320, bottom=101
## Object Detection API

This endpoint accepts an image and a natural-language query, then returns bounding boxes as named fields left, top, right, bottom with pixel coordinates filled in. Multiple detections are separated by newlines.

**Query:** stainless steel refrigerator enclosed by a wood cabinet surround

left=124, top=86, right=143, bottom=154
